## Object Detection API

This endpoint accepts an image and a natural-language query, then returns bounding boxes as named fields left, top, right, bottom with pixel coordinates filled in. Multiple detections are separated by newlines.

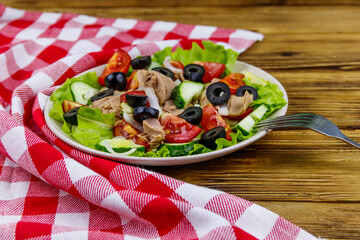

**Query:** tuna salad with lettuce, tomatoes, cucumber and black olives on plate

left=49, top=41, right=287, bottom=157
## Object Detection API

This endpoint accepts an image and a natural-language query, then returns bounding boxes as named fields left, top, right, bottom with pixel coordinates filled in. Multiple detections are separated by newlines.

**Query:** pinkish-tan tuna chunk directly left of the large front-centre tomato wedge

left=139, top=118, right=165, bottom=148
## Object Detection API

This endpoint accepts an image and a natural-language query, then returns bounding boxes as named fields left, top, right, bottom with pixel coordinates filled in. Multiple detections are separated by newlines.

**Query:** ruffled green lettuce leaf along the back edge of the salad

left=152, top=41, right=239, bottom=75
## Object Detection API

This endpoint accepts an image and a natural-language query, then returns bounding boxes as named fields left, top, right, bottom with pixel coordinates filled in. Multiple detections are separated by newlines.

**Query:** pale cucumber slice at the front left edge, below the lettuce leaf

left=95, top=137, right=145, bottom=153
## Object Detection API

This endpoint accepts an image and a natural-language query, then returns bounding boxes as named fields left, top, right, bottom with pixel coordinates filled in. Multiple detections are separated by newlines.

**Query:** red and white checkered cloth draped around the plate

left=0, top=5, right=316, bottom=240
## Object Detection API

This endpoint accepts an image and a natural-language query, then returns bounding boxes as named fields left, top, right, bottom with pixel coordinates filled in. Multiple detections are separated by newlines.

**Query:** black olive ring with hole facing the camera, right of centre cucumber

left=206, top=82, right=231, bottom=105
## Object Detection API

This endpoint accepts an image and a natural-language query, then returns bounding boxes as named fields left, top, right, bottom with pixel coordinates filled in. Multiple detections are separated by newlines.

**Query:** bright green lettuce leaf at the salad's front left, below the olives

left=71, top=107, right=115, bottom=148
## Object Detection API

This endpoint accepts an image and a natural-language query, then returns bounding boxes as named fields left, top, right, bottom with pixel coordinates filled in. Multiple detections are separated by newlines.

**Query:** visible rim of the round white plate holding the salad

left=44, top=61, right=288, bottom=166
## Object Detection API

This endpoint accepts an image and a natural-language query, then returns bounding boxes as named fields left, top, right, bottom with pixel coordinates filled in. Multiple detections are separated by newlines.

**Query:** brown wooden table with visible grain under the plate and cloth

left=0, top=0, right=360, bottom=239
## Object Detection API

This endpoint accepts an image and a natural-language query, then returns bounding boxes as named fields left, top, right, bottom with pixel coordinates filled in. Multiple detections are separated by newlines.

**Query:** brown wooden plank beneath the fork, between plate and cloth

left=151, top=130, right=360, bottom=202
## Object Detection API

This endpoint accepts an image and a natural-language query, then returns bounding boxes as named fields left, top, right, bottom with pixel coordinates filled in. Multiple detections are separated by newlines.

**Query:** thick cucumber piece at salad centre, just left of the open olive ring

left=172, top=81, right=205, bottom=109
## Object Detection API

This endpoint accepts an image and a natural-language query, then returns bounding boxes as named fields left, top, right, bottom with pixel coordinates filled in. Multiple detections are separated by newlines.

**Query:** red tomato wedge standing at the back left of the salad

left=98, top=49, right=131, bottom=86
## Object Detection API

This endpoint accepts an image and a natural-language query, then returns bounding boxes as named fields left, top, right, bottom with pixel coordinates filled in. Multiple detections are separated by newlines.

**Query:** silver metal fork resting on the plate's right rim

left=254, top=113, right=360, bottom=148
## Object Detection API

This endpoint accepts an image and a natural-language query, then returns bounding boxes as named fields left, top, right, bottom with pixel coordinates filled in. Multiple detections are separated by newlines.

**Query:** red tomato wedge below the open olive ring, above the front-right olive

left=200, top=103, right=232, bottom=141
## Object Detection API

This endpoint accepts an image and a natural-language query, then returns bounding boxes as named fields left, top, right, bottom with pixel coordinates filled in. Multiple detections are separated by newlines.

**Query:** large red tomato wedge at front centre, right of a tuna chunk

left=160, top=114, right=201, bottom=143
